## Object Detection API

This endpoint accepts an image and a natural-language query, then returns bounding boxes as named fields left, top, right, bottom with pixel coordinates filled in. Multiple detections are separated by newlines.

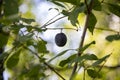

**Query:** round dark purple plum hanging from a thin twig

left=55, top=32, right=67, bottom=47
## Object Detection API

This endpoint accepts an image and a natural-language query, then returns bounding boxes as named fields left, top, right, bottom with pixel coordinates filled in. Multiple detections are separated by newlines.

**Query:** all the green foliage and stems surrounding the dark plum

left=0, top=0, right=120, bottom=80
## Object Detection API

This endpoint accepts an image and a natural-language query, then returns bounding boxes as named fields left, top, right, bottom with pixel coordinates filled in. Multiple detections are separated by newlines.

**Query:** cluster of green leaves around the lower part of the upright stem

left=49, top=41, right=111, bottom=78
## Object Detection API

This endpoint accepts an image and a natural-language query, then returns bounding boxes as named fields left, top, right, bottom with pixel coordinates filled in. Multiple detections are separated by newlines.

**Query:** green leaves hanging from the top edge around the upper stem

left=48, top=0, right=120, bottom=34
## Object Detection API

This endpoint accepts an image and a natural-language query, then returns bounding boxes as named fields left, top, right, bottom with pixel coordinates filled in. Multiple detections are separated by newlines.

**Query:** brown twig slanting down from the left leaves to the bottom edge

left=23, top=44, right=65, bottom=80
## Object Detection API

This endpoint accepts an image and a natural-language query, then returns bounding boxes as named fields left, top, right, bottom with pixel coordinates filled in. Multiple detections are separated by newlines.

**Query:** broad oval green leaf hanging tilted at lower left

left=6, top=49, right=21, bottom=69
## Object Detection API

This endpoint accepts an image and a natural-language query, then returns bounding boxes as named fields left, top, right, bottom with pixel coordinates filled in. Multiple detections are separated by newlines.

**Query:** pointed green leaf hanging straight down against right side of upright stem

left=88, top=13, right=97, bottom=34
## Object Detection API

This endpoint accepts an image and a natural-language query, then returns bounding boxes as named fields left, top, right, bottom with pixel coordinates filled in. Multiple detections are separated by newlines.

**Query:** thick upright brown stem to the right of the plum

left=70, top=0, right=94, bottom=80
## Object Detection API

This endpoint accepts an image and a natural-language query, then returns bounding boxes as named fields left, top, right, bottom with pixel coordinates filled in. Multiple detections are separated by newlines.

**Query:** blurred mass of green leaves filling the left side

left=0, top=0, right=48, bottom=80
